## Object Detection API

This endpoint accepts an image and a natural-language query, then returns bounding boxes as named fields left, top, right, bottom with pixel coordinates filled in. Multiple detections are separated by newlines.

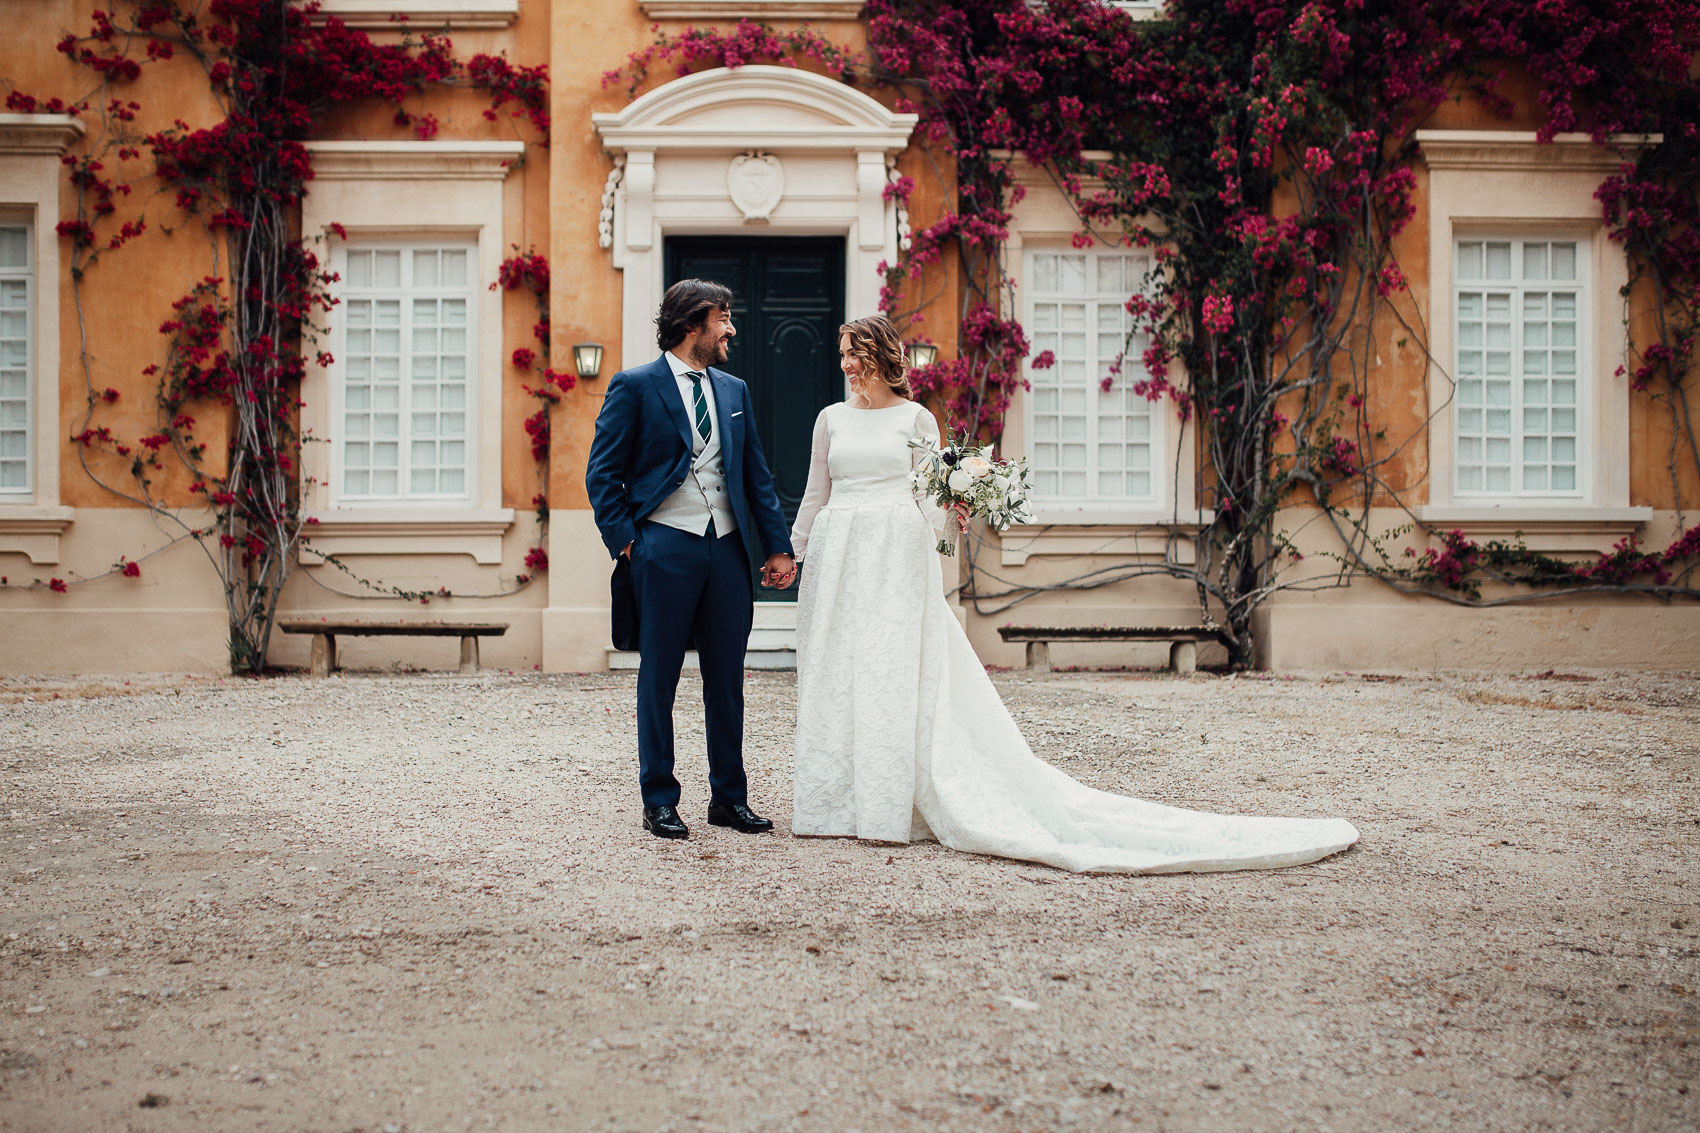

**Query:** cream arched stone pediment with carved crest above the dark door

left=593, top=66, right=916, bottom=366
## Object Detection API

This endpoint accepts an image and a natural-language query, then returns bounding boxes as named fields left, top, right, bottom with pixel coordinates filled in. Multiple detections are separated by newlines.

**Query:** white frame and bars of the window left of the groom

left=332, top=236, right=479, bottom=507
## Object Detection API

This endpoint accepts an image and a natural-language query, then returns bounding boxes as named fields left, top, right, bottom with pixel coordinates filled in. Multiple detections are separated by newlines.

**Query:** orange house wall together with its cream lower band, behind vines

left=0, top=13, right=1700, bottom=669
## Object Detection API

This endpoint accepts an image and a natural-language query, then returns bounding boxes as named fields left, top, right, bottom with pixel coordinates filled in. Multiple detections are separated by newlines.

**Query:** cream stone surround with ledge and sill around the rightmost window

left=1413, top=129, right=1661, bottom=551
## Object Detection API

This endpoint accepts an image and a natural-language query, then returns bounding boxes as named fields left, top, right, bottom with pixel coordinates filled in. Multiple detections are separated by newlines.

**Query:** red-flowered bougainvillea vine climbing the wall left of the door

left=7, top=0, right=549, bottom=672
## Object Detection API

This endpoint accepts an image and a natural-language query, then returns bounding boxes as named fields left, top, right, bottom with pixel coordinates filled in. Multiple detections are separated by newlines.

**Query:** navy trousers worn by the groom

left=632, top=522, right=753, bottom=806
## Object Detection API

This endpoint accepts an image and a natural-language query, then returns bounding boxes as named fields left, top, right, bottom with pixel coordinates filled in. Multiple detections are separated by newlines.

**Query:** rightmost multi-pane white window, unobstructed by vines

left=1454, top=240, right=1586, bottom=495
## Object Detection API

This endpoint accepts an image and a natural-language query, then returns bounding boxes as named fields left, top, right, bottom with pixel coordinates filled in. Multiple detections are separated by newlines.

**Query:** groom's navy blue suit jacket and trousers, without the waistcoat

left=585, top=348, right=791, bottom=806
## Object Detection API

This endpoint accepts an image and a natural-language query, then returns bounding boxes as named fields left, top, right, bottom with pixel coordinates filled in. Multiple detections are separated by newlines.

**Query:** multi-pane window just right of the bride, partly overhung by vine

left=1023, top=252, right=1159, bottom=504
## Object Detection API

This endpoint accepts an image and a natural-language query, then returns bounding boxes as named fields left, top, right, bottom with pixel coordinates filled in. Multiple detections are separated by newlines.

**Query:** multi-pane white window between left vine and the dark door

left=338, top=247, right=474, bottom=498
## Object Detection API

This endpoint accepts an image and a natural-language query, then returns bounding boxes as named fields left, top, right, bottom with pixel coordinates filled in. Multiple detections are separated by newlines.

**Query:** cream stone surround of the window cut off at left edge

left=0, top=114, right=83, bottom=565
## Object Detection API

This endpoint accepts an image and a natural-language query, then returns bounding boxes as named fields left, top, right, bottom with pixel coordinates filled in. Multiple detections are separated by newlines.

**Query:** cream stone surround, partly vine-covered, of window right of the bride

left=1000, top=151, right=1214, bottom=567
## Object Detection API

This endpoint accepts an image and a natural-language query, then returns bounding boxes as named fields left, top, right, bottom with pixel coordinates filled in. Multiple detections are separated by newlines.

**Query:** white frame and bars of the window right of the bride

left=1020, top=242, right=1170, bottom=512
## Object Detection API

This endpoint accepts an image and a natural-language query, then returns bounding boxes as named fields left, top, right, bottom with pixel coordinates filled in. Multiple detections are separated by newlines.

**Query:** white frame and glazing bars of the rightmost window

left=1448, top=228, right=1600, bottom=502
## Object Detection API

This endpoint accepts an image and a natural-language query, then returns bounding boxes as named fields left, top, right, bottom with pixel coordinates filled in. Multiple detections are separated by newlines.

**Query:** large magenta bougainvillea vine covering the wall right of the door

left=610, top=0, right=1700, bottom=665
